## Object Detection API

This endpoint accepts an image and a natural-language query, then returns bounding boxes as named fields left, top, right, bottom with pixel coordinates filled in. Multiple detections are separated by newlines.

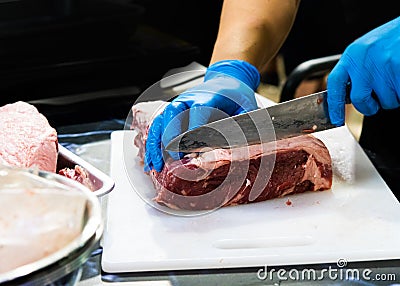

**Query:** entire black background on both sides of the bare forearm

left=0, top=0, right=400, bottom=126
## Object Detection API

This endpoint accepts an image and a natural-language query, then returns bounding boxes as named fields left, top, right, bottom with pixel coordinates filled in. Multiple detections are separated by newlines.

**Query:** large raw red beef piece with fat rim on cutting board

left=131, top=100, right=332, bottom=210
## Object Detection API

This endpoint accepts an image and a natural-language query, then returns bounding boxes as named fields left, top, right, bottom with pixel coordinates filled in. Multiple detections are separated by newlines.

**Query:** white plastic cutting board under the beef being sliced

left=101, top=126, right=400, bottom=273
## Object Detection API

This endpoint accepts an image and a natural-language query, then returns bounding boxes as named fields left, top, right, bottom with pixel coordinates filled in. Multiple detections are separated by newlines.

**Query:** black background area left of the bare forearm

left=0, top=0, right=222, bottom=119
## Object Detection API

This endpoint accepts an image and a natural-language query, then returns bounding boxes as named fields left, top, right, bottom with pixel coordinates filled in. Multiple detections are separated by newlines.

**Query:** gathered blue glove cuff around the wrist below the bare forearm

left=204, top=60, right=260, bottom=91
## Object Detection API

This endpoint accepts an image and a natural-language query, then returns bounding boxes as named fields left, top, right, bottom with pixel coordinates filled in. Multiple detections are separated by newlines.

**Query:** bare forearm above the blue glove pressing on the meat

left=210, top=0, right=300, bottom=70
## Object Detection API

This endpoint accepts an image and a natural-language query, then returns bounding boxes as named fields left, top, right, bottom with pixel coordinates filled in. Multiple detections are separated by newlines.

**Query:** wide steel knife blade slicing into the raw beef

left=165, top=90, right=336, bottom=153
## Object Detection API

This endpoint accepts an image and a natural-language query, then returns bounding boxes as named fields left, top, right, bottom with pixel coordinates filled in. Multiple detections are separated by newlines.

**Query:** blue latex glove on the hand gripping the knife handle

left=328, top=17, right=400, bottom=126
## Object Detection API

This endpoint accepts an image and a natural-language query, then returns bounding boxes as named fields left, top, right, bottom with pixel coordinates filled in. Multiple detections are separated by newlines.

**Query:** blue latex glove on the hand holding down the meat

left=144, top=60, right=260, bottom=172
